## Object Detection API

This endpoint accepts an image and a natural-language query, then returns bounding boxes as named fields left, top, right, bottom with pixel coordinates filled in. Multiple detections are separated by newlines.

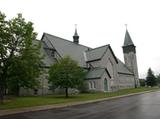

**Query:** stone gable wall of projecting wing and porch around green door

left=87, top=49, right=122, bottom=91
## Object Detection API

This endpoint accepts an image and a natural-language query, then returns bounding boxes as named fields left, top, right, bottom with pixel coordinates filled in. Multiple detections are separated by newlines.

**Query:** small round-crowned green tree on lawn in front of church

left=48, top=56, right=85, bottom=97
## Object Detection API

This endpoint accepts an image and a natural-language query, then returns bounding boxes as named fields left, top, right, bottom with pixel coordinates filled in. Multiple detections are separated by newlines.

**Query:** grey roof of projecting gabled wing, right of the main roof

left=86, top=45, right=108, bottom=61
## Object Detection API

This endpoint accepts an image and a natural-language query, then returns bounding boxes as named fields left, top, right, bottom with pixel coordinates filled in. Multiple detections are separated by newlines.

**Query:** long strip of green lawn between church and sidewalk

left=0, top=88, right=159, bottom=110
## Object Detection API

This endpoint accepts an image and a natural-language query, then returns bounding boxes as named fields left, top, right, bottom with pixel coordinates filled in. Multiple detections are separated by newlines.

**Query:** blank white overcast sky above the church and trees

left=0, top=0, right=160, bottom=78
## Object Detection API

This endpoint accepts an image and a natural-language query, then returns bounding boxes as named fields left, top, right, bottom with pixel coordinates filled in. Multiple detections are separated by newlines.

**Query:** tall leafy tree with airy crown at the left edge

left=0, top=12, right=40, bottom=102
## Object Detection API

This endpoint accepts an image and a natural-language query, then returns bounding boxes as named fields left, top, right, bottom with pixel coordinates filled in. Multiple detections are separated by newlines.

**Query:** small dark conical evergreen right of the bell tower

left=146, top=68, right=156, bottom=87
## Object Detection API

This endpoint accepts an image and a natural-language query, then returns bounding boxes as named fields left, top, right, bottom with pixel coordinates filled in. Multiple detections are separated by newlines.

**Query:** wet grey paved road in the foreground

left=0, top=92, right=160, bottom=119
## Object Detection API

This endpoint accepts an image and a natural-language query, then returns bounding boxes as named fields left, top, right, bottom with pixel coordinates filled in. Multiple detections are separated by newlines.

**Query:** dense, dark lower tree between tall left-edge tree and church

left=8, top=41, right=42, bottom=96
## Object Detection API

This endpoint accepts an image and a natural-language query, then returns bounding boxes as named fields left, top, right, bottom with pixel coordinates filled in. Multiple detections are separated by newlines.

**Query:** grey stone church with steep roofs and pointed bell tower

left=21, top=29, right=139, bottom=94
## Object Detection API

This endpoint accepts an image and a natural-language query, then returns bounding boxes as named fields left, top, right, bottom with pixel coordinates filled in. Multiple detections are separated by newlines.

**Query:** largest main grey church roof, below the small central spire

left=42, top=33, right=91, bottom=67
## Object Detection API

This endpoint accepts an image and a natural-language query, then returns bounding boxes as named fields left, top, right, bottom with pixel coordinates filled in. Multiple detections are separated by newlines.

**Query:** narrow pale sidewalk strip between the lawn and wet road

left=0, top=91, right=158, bottom=116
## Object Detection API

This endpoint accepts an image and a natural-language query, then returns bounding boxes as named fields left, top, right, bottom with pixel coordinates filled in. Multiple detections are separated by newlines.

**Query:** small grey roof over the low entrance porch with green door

left=86, top=68, right=105, bottom=79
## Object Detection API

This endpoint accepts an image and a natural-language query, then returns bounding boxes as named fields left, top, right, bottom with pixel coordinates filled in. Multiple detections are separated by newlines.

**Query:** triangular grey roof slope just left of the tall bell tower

left=117, top=59, right=133, bottom=75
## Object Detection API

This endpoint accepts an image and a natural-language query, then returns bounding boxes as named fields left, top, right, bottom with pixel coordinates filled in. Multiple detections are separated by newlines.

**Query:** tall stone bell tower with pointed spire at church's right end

left=122, top=28, right=139, bottom=87
